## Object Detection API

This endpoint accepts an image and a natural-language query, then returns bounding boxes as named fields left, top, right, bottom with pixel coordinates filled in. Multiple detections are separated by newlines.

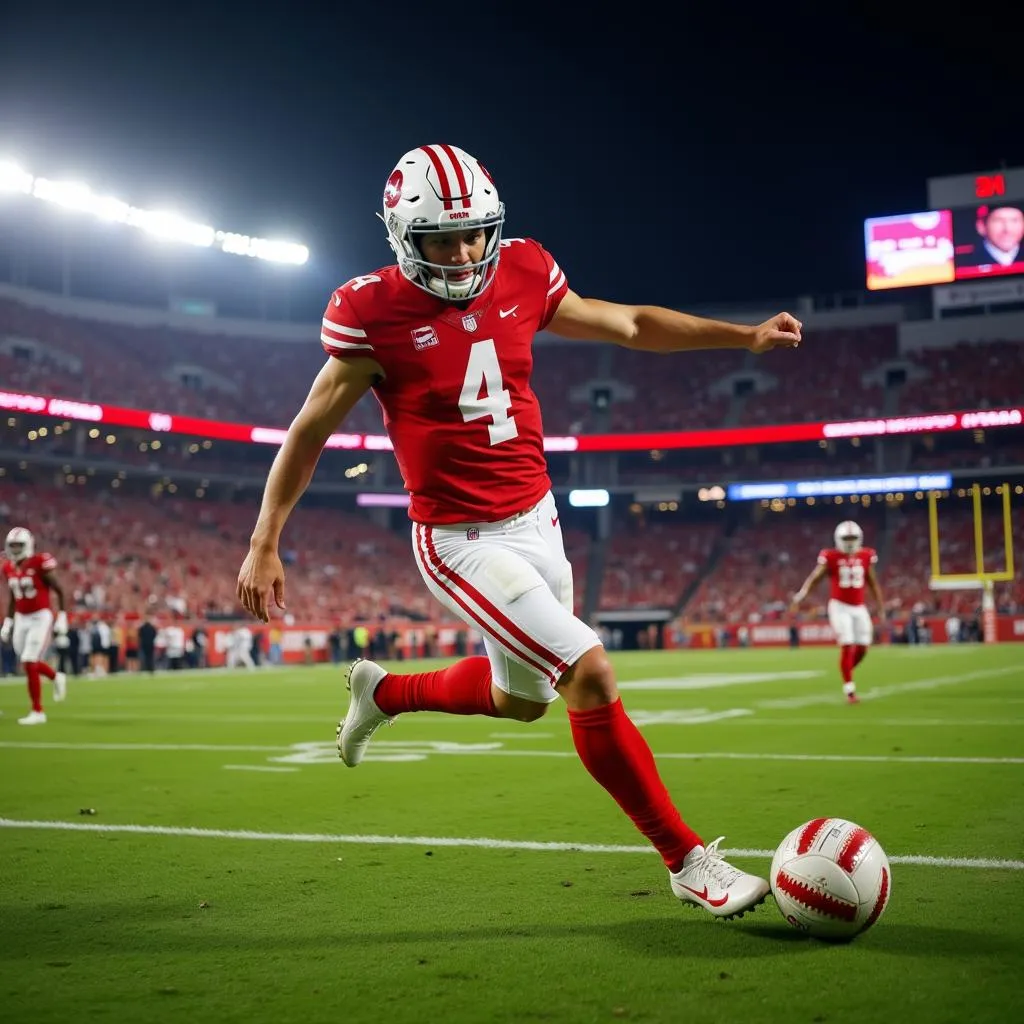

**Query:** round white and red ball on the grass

left=769, top=818, right=892, bottom=939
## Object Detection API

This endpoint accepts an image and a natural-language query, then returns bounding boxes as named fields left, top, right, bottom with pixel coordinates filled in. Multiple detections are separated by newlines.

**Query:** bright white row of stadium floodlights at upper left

left=0, top=155, right=309, bottom=266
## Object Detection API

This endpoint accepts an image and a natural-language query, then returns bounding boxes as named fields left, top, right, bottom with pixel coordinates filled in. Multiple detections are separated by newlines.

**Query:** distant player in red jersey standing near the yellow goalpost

left=790, top=519, right=886, bottom=703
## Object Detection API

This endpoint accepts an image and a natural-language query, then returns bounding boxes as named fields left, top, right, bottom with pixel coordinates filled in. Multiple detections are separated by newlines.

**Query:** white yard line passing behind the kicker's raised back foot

left=0, top=739, right=1024, bottom=765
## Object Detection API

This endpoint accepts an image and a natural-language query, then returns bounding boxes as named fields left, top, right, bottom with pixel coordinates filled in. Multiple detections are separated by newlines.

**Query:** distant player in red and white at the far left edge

left=0, top=526, right=68, bottom=725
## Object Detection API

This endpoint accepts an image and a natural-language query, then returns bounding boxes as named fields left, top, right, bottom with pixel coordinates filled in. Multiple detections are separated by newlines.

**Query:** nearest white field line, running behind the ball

left=0, top=818, right=1024, bottom=871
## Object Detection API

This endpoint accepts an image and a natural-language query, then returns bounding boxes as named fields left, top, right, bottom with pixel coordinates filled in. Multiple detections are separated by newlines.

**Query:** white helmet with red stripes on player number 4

left=381, top=144, right=505, bottom=302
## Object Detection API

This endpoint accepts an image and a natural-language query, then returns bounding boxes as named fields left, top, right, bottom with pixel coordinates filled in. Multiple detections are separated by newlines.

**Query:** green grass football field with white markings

left=0, top=645, right=1024, bottom=1024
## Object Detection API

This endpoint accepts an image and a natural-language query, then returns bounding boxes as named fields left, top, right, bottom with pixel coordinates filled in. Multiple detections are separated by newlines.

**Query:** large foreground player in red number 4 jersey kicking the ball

left=238, top=145, right=801, bottom=918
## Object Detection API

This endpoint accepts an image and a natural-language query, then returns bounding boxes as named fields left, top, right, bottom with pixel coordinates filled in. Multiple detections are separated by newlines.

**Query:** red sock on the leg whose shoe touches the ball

left=569, top=700, right=702, bottom=871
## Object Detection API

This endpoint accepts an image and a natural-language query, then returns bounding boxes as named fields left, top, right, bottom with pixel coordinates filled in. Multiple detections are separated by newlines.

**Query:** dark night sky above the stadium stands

left=0, top=0, right=1024, bottom=307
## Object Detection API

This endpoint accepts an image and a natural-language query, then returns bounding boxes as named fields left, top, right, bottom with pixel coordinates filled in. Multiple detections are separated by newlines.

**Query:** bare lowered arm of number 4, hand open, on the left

left=237, top=356, right=383, bottom=623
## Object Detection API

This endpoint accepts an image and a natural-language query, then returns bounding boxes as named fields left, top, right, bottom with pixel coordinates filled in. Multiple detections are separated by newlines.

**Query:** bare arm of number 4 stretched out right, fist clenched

left=548, top=291, right=803, bottom=354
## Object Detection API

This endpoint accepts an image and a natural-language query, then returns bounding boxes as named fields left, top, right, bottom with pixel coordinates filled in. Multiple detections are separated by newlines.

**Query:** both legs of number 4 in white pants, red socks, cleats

left=338, top=512, right=769, bottom=918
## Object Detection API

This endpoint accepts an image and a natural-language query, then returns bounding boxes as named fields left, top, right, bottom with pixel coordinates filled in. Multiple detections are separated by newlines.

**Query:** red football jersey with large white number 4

left=321, top=239, right=568, bottom=525
